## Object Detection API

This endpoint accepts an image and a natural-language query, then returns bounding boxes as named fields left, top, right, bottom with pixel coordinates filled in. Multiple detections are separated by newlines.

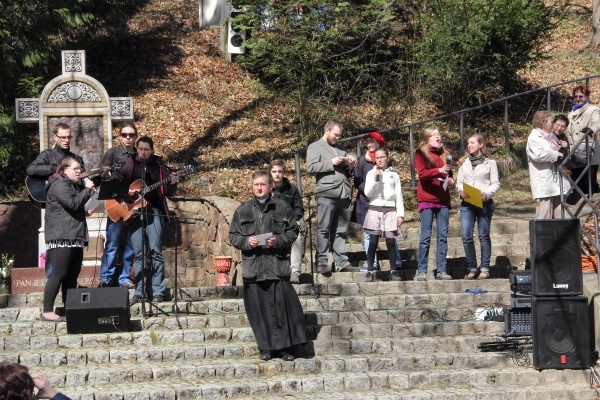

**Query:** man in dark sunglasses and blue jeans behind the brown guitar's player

left=98, top=122, right=137, bottom=289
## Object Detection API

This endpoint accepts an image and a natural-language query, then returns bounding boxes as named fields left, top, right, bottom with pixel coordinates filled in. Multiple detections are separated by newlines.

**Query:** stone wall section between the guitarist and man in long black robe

left=163, top=197, right=241, bottom=288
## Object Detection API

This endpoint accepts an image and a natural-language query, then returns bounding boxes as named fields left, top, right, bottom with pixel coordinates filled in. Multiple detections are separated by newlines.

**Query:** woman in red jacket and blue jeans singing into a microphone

left=415, top=127, right=454, bottom=281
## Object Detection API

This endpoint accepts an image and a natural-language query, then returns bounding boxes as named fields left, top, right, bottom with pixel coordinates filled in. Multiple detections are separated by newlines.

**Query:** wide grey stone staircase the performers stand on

left=0, top=214, right=597, bottom=400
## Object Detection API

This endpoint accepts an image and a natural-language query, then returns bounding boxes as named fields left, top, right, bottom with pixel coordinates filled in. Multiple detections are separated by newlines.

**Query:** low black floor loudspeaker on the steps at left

left=65, top=287, right=129, bottom=333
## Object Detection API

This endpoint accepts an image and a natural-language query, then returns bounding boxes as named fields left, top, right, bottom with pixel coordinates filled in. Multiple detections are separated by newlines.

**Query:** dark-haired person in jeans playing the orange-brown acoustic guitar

left=112, top=136, right=178, bottom=304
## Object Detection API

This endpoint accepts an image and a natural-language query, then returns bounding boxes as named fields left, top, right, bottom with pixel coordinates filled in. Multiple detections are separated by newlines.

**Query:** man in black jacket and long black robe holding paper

left=229, top=170, right=308, bottom=361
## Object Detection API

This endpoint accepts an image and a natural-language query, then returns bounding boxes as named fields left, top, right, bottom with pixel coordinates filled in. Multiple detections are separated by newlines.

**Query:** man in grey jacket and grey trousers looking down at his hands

left=306, top=120, right=356, bottom=274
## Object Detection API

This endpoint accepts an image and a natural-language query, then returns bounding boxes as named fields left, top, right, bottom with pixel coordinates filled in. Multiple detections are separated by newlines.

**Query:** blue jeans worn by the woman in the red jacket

left=418, top=208, right=450, bottom=273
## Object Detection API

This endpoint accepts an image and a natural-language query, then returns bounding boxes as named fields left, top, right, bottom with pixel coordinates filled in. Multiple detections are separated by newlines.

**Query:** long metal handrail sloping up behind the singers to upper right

left=294, top=74, right=600, bottom=193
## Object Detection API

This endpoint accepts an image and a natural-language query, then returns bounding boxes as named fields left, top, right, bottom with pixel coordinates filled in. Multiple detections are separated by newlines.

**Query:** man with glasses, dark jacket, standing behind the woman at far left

left=26, top=122, right=87, bottom=278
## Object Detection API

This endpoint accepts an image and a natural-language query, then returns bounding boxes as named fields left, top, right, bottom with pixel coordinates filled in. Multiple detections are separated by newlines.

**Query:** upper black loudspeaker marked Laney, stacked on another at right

left=529, top=219, right=583, bottom=296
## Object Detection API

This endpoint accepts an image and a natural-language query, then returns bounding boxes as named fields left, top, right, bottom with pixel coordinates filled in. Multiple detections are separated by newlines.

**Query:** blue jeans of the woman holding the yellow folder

left=460, top=200, right=494, bottom=272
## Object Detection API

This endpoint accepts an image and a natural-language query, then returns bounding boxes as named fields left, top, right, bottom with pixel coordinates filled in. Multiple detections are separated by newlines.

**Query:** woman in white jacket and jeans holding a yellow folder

left=456, top=134, right=500, bottom=280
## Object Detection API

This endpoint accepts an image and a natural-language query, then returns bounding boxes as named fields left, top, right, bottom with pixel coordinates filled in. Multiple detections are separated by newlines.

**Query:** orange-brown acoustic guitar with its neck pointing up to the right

left=105, top=165, right=194, bottom=224
